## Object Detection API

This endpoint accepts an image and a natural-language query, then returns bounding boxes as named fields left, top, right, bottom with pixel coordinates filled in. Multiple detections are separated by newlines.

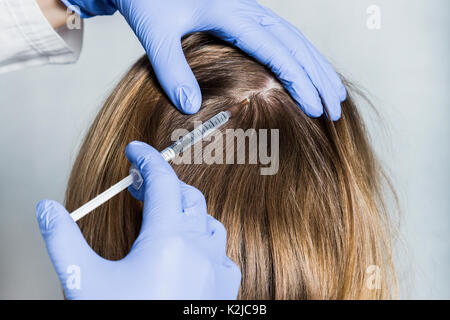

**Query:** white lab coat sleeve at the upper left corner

left=0, top=0, right=83, bottom=73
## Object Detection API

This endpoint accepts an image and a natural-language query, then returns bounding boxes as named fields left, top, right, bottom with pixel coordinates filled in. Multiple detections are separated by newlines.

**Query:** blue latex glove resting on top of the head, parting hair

left=62, top=0, right=346, bottom=120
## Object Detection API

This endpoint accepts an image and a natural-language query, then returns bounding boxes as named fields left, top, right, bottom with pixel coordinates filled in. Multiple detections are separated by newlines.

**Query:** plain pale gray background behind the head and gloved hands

left=0, top=0, right=450, bottom=299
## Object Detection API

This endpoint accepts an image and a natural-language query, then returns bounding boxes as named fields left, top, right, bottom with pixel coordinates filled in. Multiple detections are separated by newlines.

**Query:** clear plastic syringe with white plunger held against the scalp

left=70, top=99, right=250, bottom=221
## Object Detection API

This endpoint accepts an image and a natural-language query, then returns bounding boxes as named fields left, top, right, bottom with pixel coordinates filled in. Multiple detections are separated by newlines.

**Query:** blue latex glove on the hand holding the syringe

left=37, top=142, right=241, bottom=299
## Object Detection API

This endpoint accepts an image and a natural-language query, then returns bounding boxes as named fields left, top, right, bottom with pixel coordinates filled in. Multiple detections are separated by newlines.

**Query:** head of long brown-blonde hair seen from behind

left=66, top=34, right=395, bottom=299
